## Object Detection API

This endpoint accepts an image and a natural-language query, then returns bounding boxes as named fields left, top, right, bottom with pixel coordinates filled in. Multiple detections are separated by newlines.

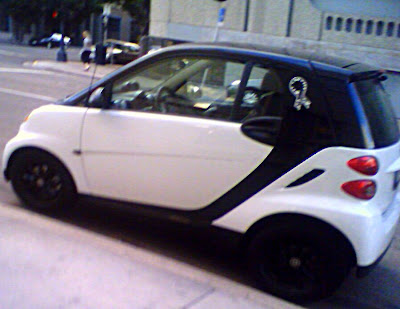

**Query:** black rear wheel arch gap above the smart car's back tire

left=240, top=212, right=357, bottom=266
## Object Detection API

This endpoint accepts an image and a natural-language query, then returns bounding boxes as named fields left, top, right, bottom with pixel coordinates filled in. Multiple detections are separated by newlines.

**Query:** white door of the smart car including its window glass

left=81, top=56, right=273, bottom=210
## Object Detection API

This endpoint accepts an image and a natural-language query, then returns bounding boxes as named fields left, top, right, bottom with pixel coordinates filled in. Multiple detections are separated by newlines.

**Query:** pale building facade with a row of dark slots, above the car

left=150, top=0, right=400, bottom=51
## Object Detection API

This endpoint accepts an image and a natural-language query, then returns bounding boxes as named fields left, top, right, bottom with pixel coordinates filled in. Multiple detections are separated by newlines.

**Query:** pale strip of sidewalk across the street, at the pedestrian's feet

left=24, top=60, right=121, bottom=78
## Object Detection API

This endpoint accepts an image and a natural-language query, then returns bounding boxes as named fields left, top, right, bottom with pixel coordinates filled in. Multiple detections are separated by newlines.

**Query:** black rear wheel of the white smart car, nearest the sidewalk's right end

left=247, top=220, right=352, bottom=302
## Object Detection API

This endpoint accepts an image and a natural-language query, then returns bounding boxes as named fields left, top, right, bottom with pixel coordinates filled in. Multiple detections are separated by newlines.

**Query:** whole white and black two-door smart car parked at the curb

left=3, top=44, right=400, bottom=300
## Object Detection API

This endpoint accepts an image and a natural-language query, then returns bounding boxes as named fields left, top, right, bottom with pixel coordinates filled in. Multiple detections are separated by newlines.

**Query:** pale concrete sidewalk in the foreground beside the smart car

left=0, top=205, right=299, bottom=309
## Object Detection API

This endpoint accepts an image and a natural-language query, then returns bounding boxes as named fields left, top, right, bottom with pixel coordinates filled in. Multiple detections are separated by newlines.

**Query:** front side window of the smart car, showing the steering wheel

left=112, top=57, right=250, bottom=120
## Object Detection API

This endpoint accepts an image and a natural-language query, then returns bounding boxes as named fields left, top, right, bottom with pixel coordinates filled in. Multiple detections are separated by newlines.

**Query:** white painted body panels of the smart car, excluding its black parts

left=2, top=105, right=400, bottom=266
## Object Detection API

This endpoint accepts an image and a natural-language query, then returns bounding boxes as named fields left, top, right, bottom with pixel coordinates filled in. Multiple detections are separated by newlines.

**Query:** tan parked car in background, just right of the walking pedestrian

left=90, top=39, right=140, bottom=64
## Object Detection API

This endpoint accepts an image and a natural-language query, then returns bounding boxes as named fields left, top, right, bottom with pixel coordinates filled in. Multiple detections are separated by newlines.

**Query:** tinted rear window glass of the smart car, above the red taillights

left=355, top=78, right=399, bottom=148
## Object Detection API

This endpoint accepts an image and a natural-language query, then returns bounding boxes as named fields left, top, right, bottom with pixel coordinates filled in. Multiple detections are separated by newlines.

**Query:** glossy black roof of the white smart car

left=169, top=42, right=379, bottom=75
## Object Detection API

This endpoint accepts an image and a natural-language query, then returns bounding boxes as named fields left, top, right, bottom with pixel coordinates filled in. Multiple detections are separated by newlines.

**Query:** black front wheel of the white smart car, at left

left=9, top=149, right=77, bottom=211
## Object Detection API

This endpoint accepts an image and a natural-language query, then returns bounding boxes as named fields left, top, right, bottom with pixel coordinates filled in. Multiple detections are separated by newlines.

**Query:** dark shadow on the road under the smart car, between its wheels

left=45, top=196, right=255, bottom=287
